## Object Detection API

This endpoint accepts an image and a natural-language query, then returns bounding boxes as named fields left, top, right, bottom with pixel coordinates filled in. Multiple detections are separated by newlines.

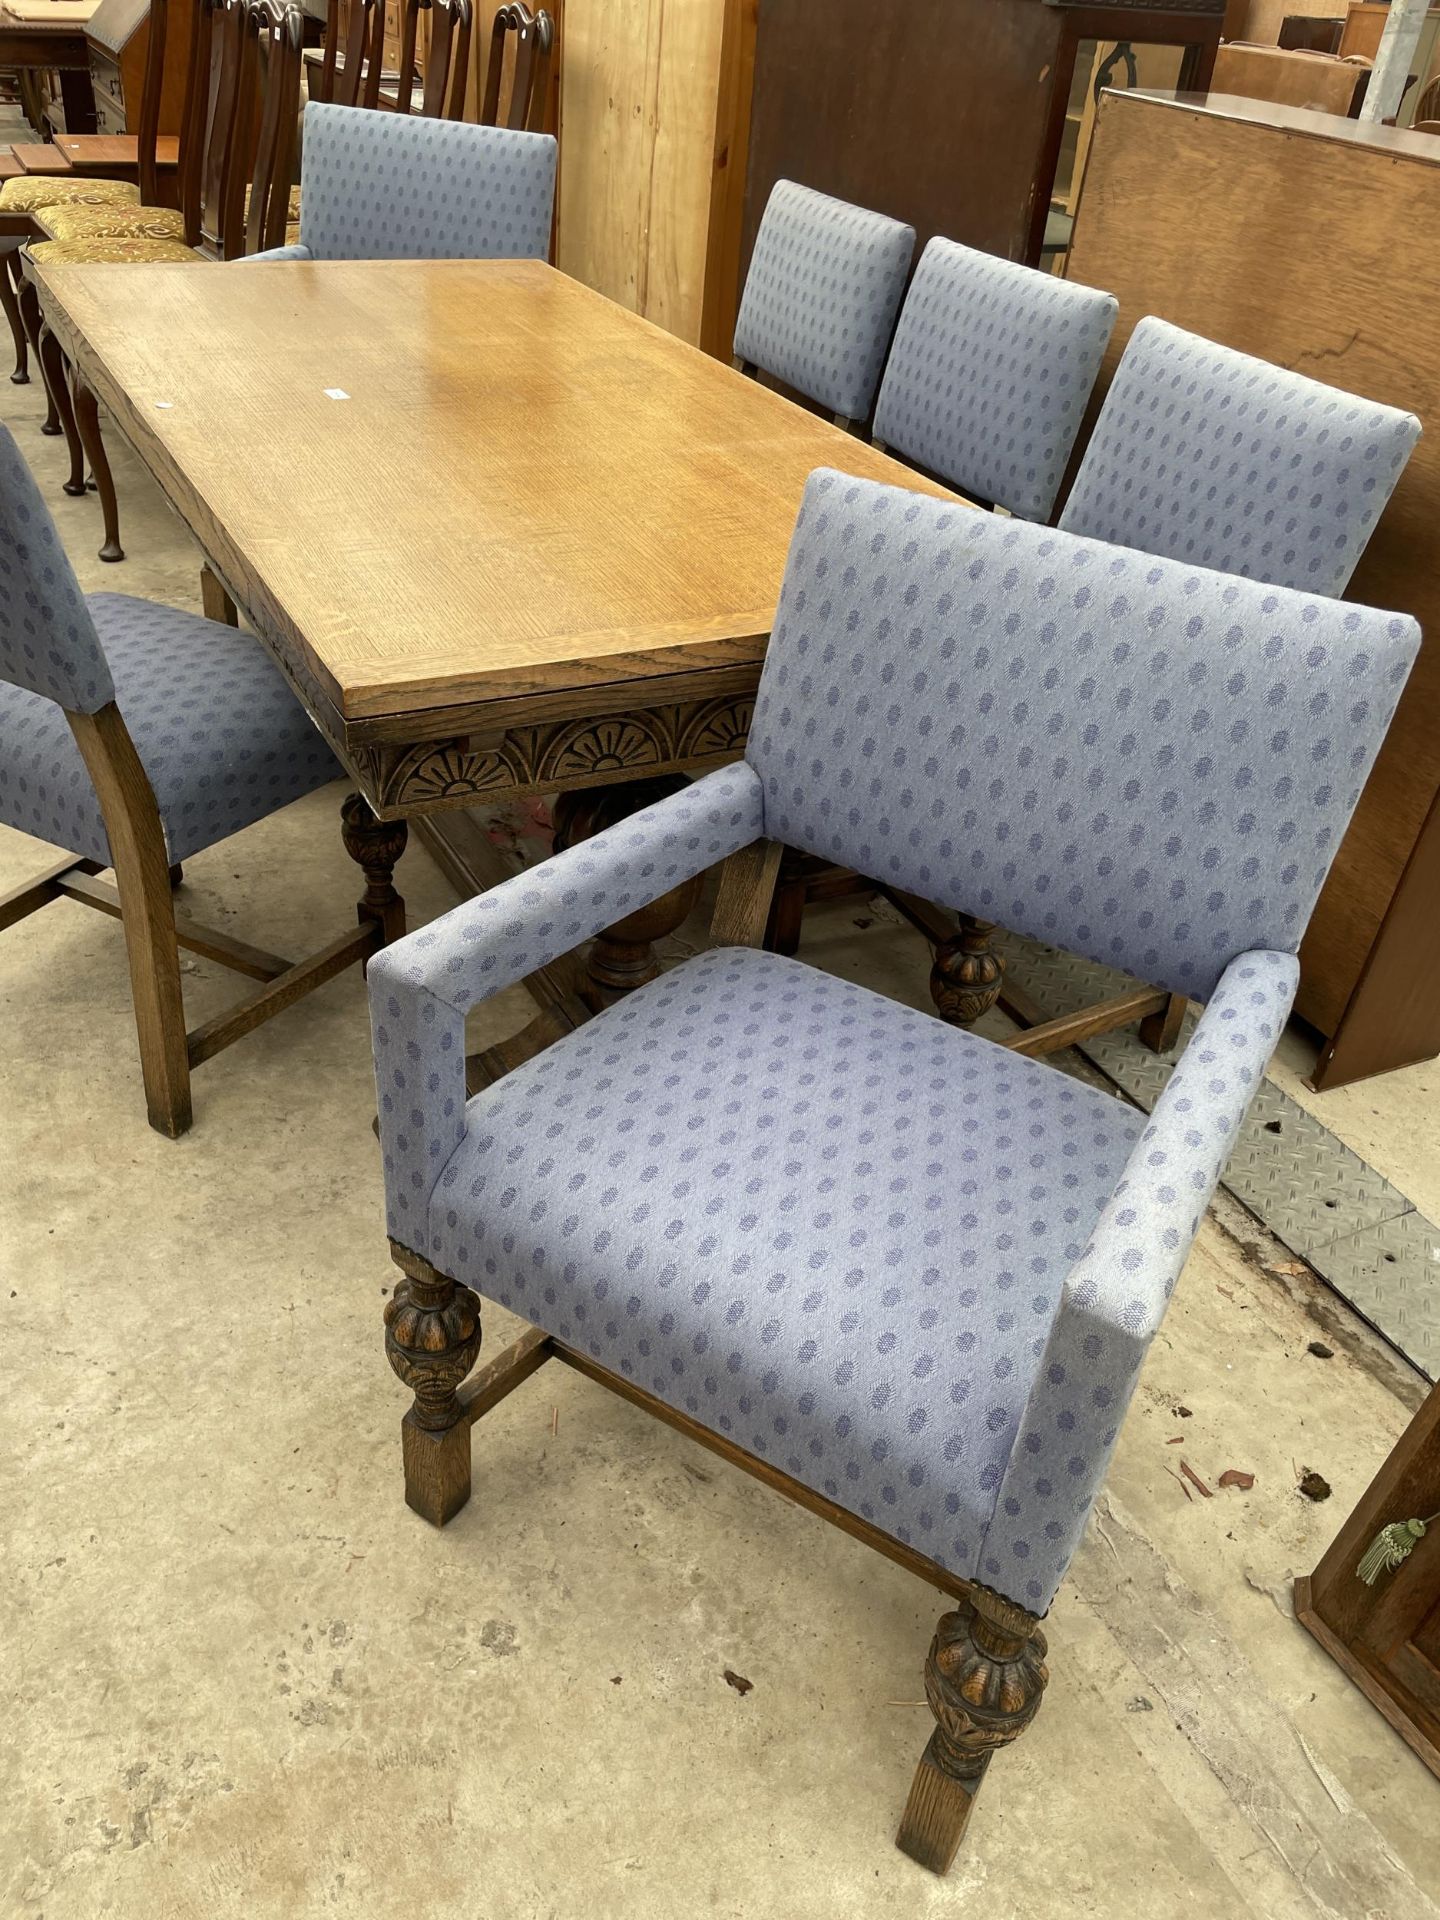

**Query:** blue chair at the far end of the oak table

left=250, top=102, right=555, bottom=263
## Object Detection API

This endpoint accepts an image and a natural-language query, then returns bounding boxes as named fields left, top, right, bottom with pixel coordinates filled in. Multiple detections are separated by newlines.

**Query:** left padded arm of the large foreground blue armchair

left=369, top=760, right=764, bottom=1254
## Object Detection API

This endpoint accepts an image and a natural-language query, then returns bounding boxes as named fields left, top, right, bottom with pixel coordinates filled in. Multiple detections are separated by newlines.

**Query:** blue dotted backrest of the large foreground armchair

left=745, top=470, right=1419, bottom=1000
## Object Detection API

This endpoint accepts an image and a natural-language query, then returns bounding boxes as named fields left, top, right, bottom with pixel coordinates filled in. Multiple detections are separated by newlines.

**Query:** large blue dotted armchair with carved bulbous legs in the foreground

left=369, top=470, right=1419, bottom=1870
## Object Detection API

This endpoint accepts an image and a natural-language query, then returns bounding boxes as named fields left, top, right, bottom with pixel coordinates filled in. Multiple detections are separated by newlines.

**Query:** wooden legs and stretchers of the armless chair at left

left=0, top=660, right=407, bottom=1139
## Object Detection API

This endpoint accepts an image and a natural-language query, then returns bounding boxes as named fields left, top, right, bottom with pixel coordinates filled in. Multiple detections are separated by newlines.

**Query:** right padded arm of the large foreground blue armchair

left=981, top=952, right=1300, bottom=1613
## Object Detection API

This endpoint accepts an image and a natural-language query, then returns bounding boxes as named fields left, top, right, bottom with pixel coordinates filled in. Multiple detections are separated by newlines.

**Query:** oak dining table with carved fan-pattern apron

left=36, top=249, right=963, bottom=1085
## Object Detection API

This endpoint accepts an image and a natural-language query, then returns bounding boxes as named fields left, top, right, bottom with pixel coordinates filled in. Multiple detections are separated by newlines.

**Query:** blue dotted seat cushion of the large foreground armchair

left=430, top=948, right=1144, bottom=1576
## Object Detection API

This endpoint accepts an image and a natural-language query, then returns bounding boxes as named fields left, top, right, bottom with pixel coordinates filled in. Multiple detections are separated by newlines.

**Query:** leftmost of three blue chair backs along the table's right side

left=735, top=180, right=916, bottom=420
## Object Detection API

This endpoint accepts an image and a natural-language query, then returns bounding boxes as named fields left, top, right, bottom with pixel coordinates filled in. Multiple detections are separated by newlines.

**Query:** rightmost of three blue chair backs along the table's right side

left=1060, top=319, right=1421, bottom=595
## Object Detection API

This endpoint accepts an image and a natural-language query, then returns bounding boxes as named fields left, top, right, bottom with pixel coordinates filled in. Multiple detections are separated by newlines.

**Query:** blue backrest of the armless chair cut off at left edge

left=0, top=426, right=115, bottom=714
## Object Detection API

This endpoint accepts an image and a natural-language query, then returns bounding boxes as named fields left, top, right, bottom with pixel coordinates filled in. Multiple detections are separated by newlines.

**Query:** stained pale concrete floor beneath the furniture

left=0, top=360, right=1440, bottom=1920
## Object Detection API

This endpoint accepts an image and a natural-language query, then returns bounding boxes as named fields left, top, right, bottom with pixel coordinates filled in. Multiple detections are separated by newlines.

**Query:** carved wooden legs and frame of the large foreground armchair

left=384, top=839, right=1048, bottom=1874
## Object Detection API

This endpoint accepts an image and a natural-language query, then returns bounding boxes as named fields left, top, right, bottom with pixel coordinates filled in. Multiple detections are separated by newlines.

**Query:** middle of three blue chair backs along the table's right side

left=876, top=238, right=1119, bottom=520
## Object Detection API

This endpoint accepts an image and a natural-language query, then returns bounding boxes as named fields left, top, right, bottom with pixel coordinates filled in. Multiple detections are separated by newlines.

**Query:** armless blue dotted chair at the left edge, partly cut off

left=0, top=426, right=405, bottom=1137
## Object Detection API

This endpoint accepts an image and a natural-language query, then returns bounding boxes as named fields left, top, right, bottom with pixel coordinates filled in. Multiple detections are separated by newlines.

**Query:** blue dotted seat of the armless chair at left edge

left=0, top=593, right=340, bottom=866
